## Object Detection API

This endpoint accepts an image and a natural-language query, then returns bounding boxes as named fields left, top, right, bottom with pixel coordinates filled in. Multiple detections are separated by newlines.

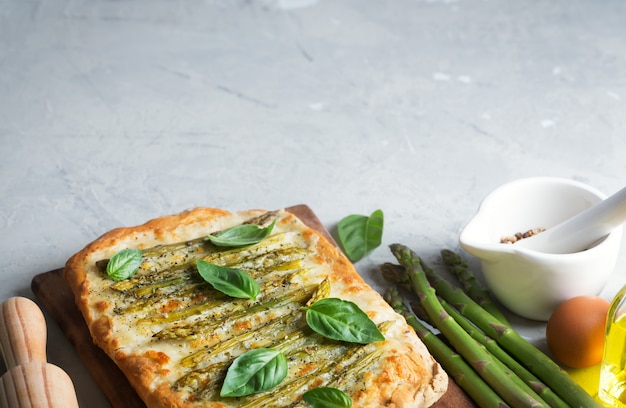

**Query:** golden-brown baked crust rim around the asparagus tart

left=65, top=208, right=448, bottom=408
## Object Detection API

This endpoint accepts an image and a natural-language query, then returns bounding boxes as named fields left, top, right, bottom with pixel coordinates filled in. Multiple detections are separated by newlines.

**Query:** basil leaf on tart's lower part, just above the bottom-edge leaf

left=220, top=348, right=288, bottom=397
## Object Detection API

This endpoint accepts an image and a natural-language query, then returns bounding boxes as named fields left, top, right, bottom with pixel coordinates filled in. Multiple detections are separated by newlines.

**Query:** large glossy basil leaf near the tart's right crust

left=303, top=298, right=385, bottom=344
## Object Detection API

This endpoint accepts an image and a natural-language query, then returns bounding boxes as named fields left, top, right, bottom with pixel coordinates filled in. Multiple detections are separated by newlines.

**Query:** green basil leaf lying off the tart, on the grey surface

left=337, top=210, right=384, bottom=262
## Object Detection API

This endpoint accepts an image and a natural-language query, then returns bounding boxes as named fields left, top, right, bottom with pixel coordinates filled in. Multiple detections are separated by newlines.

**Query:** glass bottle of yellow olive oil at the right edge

left=598, top=286, right=626, bottom=408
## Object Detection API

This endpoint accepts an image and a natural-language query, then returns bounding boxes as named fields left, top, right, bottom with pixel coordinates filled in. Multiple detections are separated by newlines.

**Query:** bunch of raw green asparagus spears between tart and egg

left=383, top=244, right=599, bottom=408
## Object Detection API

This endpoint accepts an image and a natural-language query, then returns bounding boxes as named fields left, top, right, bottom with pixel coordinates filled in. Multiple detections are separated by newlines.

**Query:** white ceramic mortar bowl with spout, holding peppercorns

left=459, top=177, right=623, bottom=321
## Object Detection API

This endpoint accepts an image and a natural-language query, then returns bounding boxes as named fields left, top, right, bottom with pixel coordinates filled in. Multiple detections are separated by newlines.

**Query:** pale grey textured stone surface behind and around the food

left=0, top=0, right=626, bottom=408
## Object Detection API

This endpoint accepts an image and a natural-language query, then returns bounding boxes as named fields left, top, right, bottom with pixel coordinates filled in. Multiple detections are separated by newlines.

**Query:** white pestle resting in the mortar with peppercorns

left=515, top=187, right=626, bottom=254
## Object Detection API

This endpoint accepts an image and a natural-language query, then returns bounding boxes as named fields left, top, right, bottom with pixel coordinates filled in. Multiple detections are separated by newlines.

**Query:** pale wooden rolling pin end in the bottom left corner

left=0, top=297, right=78, bottom=408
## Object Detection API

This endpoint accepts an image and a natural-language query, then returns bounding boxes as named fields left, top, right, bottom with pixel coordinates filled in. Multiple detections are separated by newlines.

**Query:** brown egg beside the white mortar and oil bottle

left=546, top=296, right=610, bottom=368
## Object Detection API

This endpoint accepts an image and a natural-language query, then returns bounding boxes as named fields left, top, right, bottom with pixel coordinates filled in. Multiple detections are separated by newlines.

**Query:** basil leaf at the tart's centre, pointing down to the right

left=196, top=259, right=261, bottom=300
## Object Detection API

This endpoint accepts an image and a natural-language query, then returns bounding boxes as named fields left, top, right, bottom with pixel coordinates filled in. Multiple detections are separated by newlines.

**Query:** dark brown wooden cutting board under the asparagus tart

left=31, top=205, right=476, bottom=408
